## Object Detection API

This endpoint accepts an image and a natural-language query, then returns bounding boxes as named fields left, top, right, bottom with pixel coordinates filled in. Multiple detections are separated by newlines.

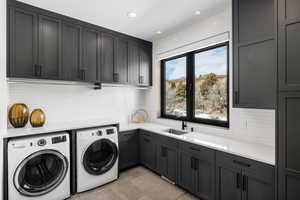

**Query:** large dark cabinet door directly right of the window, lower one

left=234, top=40, right=276, bottom=109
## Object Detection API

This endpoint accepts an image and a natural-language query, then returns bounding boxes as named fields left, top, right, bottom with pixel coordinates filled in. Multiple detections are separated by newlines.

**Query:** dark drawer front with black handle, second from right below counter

left=179, top=142, right=215, bottom=161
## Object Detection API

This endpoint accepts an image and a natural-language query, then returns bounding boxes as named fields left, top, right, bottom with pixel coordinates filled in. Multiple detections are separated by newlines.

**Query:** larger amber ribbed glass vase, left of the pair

left=8, top=103, right=29, bottom=128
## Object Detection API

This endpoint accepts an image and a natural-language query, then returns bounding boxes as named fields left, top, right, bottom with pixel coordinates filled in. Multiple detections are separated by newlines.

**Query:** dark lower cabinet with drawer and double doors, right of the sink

left=178, top=143, right=215, bottom=200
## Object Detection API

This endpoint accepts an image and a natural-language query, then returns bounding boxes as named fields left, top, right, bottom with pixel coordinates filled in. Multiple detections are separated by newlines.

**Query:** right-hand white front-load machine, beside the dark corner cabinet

left=77, top=127, right=119, bottom=192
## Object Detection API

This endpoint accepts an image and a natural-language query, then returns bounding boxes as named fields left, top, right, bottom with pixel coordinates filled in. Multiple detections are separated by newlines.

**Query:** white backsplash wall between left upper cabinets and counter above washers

left=8, top=83, right=145, bottom=126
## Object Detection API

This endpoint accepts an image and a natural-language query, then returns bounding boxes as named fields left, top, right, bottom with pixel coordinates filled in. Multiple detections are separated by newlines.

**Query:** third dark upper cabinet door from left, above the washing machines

left=62, top=23, right=82, bottom=81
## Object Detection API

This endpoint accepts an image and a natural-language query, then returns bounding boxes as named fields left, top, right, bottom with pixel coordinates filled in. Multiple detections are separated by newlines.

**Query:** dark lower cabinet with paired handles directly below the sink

left=157, top=136, right=178, bottom=183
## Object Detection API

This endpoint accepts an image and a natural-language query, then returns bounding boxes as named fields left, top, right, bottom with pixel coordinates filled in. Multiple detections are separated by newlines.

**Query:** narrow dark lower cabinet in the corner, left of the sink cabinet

left=140, top=130, right=157, bottom=171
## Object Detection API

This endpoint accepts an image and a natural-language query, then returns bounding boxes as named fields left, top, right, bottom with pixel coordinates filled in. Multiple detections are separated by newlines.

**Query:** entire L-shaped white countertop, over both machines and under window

left=2, top=119, right=275, bottom=165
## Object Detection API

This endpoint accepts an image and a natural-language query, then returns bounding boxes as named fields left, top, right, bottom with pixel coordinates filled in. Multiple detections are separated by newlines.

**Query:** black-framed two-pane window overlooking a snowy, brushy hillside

left=161, top=42, right=229, bottom=127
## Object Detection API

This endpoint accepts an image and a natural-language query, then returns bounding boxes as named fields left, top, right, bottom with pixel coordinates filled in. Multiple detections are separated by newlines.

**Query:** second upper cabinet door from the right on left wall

left=128, top=43, right=140, bottom=85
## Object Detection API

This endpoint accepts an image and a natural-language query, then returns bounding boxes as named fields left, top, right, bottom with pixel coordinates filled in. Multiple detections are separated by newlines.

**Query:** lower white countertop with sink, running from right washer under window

left=120, top=123, right=275, bottom=165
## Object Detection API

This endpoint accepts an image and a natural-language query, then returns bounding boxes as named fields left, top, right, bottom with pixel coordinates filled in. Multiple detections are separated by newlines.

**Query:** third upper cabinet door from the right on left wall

left=114, top=39, right=128, bottom=83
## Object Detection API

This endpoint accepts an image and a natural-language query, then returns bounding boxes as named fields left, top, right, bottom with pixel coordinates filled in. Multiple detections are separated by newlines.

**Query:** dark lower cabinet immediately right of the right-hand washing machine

left=119, top=130, right=140, bottom=170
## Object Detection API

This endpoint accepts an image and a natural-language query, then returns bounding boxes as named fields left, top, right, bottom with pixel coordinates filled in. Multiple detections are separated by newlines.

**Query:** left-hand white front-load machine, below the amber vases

left=7, top=133, right=70, bottom=200
